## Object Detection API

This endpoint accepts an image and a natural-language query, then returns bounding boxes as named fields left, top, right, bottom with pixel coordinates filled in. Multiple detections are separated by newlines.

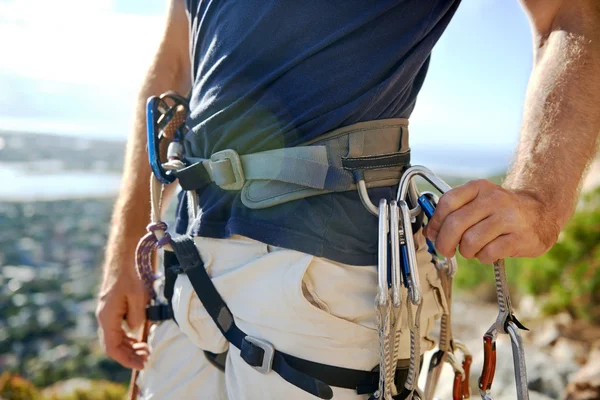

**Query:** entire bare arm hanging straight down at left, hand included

left=96, top=0, right=190, bottom=369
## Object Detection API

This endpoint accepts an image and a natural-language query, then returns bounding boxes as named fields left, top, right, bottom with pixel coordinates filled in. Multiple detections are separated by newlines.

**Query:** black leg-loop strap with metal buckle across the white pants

left=171, top=236, right=403, bottom=399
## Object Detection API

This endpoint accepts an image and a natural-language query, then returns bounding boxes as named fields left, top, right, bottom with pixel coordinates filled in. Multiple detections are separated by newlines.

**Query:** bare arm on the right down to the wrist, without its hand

left=505, top=0, right=600, bottom=230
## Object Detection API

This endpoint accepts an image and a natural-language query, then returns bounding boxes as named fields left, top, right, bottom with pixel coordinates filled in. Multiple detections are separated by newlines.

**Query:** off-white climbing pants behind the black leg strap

left=140, top=233, right=447, bottom=400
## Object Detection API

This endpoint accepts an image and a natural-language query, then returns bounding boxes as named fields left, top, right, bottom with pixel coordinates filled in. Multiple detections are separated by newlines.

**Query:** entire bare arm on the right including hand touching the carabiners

left=426, top=0, right=600, bottom=263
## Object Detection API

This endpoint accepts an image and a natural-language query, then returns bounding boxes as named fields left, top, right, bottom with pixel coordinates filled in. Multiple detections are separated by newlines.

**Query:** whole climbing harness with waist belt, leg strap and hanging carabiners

left=132, top=93, right=526, bottom=400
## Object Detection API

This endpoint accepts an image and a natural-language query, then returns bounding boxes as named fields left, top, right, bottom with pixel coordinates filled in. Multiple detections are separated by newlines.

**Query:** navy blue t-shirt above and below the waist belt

left=179, top=0, right=460, bottom=265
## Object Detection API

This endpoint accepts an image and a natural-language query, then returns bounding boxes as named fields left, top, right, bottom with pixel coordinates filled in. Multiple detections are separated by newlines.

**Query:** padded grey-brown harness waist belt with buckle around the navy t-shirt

left=173, top=118, right=410, bottom=208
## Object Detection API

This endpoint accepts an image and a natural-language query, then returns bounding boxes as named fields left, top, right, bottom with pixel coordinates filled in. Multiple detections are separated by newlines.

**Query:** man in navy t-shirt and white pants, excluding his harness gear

left=97, top=0, right=600, bottom=399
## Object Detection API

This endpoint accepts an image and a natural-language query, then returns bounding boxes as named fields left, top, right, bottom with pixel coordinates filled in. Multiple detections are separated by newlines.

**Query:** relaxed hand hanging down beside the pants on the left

left=96, top=261, right=149, bottom=369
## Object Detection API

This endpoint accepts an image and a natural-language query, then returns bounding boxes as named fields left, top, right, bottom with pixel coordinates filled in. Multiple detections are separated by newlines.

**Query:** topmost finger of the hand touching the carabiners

left=426, top=180, right=493, bottom=242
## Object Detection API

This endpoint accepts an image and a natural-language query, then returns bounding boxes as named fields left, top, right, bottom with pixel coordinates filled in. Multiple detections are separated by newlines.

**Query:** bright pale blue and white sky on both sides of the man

left=0, top=0, right=532, bottom=151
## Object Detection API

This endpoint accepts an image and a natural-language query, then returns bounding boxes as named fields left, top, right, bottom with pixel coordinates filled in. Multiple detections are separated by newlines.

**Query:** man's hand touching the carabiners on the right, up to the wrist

left=425, top=180, right=560, bottom=264
